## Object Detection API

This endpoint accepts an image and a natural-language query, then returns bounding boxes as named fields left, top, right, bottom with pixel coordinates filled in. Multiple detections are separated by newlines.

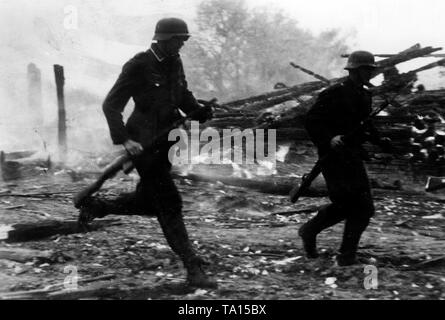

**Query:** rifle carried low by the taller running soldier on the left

left=73, top=99, right=216, bottom=208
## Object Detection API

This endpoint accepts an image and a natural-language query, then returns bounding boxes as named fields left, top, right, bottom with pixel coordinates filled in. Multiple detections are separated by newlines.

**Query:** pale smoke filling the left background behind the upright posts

left=0, top=0, right=438, bottom=169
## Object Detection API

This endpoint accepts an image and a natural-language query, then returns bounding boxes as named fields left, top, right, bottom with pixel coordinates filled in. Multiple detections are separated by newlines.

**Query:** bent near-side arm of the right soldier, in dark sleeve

left=304, top=92, right=334, bottom=149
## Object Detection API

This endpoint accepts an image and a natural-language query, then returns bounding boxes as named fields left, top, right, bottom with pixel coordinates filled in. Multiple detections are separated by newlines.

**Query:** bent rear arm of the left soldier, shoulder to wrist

left=102, top=58, right=140, bottom=144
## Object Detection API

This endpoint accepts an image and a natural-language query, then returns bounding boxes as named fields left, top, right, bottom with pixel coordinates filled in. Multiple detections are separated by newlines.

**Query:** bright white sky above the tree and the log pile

left=107, top=0, right=445, bottom=53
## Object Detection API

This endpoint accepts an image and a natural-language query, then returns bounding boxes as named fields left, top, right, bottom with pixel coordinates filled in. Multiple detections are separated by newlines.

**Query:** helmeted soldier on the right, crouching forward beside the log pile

left=299, top=51, right=390, bottom=266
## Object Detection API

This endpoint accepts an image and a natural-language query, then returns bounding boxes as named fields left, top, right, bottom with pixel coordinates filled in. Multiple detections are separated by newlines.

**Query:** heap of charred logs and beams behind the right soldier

left=207, top=44, right=445, bottom=175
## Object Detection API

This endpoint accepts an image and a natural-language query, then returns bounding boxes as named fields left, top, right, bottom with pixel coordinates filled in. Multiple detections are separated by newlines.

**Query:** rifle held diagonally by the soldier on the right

left=289, top=81, right=414, bottom=203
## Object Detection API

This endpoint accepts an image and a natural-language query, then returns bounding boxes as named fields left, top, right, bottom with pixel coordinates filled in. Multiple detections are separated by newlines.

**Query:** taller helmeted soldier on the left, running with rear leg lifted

left=79, top=18, right=216, bottom=288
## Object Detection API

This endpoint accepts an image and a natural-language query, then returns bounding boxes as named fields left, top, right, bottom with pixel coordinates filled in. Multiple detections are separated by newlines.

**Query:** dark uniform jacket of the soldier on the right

left=305, top=78, right=380, bottom=154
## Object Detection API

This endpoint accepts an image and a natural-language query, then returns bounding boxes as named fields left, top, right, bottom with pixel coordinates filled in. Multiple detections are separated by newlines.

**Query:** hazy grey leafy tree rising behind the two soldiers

left=184, top=0, right=348, bottom=101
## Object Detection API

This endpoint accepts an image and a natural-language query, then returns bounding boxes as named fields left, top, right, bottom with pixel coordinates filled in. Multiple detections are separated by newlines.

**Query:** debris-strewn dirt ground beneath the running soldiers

left=0, top=173, right=445, bottom=300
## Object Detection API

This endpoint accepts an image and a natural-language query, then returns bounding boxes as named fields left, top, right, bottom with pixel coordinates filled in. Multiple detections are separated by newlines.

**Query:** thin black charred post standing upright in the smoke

left=54, top=64, right=67, bottom=161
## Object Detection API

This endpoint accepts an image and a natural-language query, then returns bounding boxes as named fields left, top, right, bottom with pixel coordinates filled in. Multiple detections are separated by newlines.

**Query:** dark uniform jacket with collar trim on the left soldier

left=103, top=44, right=199, bottom=147
